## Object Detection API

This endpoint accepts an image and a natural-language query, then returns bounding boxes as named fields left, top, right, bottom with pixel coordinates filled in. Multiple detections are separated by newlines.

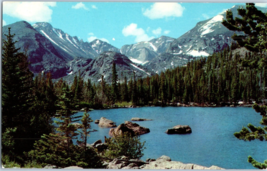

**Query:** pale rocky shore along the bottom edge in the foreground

left=105, top=155, right=223, bottom=170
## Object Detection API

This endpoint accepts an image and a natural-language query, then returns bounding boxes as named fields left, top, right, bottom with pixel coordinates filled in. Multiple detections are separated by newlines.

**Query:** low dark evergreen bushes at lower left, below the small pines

left=27, top=134, right=102, bottom=168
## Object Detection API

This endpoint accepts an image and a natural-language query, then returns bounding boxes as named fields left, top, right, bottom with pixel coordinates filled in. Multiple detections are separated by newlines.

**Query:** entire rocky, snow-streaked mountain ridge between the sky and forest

left=3, top=6, right=267, bottom=82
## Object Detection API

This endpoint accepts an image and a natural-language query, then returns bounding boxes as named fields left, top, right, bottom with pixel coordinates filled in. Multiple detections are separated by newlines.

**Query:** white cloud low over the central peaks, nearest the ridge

left=122, top=23, right=154, bottom=42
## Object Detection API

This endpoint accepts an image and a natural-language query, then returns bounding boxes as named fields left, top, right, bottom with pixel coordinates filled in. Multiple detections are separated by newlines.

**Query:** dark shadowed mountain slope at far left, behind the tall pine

left=2, top=21, right=71, bottom=78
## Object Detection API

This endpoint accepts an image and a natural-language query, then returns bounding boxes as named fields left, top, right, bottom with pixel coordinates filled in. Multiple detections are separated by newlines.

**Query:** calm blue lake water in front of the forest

left=72, top=107, right=267, bottom=169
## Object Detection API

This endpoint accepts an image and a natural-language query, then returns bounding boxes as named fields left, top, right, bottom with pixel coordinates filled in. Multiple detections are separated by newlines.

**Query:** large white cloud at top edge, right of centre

left=143, top=2, right=185, bottom=19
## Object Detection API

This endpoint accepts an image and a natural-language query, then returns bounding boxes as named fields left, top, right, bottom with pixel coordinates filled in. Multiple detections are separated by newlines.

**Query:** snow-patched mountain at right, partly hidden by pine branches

left=167, top=5, right=267, bottom=57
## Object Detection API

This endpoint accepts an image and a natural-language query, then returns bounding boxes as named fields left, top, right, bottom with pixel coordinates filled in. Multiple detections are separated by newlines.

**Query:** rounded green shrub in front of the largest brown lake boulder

left=104, top=134, right=145, bottom=159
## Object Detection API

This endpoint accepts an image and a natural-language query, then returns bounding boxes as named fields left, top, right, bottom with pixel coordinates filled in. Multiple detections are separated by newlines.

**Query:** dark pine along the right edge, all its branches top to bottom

left=222, top=3, right=267, bottom=169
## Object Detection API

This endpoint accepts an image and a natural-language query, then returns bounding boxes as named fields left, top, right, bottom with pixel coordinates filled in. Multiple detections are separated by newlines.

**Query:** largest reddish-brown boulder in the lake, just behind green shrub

left=109, top=121, right=150, bottom=136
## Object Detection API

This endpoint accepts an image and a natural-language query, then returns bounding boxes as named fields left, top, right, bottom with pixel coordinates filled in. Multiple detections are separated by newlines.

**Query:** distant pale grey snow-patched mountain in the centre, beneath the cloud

left=120, top=36, right=174, bottom=64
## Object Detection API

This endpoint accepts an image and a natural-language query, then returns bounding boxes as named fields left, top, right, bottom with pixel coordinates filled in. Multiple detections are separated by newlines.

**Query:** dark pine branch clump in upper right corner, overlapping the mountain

left=222, top=3, right=267, bottom=52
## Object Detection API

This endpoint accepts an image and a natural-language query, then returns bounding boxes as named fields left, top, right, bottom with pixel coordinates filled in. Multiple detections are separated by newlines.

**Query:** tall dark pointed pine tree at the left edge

left=2, top=28, right=38, bottom=160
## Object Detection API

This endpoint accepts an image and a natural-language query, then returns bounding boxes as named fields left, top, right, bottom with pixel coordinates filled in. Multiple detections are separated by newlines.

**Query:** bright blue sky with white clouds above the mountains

left=2, top=1, right=267, bottom=48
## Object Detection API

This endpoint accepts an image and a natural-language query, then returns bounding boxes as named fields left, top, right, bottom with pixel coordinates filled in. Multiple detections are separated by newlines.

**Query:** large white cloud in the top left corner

left=3, top=1, right=56, bottom=22
